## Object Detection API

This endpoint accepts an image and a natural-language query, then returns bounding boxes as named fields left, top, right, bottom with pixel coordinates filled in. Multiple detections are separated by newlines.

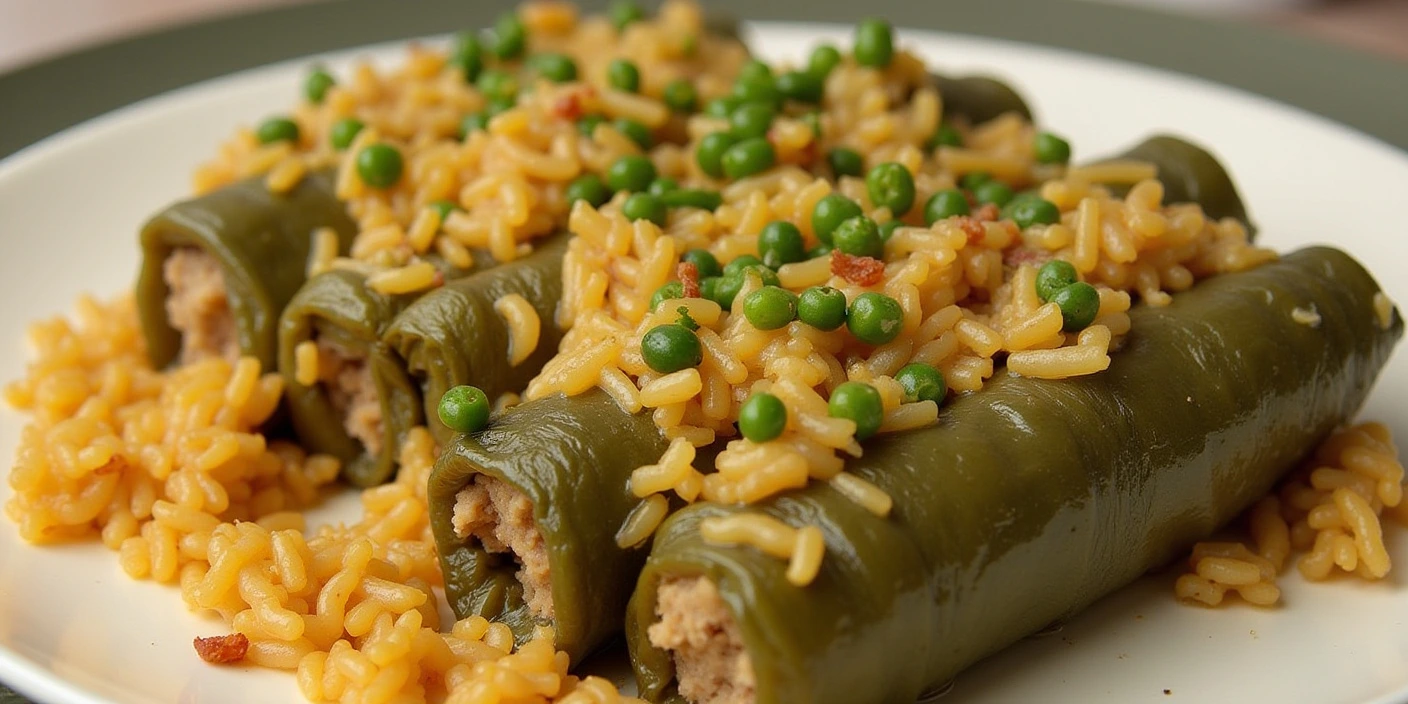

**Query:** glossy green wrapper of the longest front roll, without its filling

left=627, top=248, right=1402, bottom=704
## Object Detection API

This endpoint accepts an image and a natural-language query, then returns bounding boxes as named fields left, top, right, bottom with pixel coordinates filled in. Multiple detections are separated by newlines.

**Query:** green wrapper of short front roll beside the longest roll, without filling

left=428, top=390, right=667, bottom=662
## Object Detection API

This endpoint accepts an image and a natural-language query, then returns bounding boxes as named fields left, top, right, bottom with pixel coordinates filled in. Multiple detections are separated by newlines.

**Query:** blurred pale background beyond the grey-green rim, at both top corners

left=0, top=0, right=1408, bottom=72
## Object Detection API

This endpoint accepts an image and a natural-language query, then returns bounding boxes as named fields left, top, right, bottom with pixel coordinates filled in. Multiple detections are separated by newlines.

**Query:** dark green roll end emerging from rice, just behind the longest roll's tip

left=1111, top=135, right=1256, bottom=235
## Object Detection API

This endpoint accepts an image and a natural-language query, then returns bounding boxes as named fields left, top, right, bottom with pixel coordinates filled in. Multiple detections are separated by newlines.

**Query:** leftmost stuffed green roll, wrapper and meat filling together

left=137, top=173, right=356, bottom=369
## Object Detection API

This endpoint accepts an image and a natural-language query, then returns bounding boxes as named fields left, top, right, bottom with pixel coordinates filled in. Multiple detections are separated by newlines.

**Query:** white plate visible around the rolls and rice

left=0, top=19, right=1408, bottom=704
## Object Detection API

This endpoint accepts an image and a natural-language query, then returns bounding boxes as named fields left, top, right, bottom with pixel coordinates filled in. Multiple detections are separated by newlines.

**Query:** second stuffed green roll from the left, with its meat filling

left=279, top=255, right=489, bottom=486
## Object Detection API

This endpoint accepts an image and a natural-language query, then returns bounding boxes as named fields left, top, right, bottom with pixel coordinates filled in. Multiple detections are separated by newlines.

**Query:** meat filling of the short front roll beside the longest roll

left=453, top=474, right=552, bottom=618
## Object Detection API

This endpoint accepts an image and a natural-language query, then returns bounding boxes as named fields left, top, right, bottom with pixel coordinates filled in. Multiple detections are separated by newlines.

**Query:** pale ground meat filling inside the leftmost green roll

left=162, top=246, right=239, bottom=365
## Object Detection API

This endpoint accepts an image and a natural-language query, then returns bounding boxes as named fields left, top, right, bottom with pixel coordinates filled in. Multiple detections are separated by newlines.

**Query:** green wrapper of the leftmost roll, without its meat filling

left=137, top=172, right=356, bottom=370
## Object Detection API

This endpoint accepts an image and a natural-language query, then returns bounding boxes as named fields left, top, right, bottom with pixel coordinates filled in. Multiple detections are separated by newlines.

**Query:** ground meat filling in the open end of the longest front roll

left=646, top=577, right=756, bottom=704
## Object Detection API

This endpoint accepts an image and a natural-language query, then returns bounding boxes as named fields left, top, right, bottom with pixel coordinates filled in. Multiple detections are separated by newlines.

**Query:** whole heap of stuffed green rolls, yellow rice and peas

left=6, top=0, right=1408, bottom=704
